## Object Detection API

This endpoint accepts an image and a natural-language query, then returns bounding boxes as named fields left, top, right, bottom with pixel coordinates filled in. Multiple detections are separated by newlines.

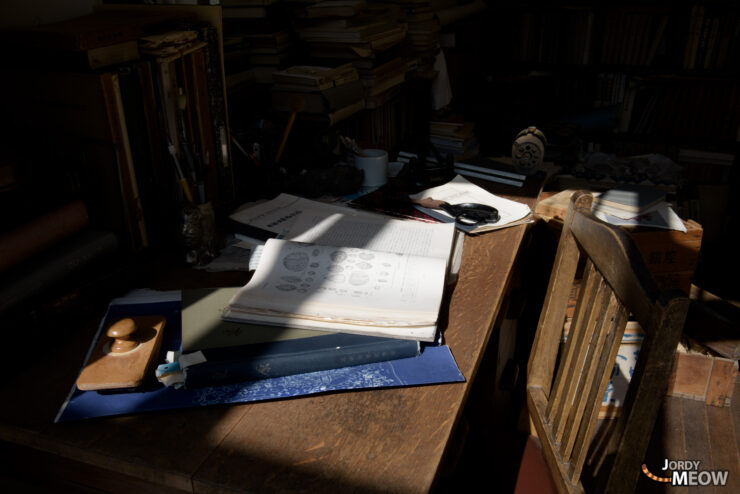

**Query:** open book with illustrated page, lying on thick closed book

left=223, top=202, right=456, bottom=341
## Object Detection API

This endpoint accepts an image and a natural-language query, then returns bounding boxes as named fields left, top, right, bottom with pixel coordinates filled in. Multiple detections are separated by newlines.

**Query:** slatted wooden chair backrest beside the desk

left=527, top=192, right=689, bottom=493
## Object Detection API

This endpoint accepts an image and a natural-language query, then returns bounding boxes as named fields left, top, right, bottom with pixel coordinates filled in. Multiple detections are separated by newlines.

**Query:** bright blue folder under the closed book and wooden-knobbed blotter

left=55, top=291, right=465, bottom=422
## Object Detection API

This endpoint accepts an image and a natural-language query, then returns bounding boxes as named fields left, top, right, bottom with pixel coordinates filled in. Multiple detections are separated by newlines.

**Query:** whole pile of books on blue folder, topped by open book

left=167, top=194, right=461, bottom=388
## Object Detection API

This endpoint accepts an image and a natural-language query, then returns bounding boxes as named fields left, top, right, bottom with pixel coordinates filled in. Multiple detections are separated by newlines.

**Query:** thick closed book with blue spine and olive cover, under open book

left=182, top=288, right=421, bottom=388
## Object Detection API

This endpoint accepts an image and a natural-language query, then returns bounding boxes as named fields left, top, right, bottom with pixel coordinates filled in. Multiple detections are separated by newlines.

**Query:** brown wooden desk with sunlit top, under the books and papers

left=0, top=176, right=541, bottom=493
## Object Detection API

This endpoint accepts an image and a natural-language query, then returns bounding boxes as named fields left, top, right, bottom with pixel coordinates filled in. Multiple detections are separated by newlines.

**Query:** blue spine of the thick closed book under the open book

left=185, top=339, right=420, bottom=388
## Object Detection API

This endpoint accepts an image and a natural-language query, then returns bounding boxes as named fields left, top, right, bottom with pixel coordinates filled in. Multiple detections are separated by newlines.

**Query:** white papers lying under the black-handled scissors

left=409, top=175, right=532, bottom=233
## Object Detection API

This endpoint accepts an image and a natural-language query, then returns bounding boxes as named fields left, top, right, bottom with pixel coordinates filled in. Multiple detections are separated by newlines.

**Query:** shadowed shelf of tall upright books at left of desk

left=0, top=5, right=234, bottom=339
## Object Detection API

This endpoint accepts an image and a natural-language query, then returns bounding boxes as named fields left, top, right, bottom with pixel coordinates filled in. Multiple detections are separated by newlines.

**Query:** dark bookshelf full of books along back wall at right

left=442, top=0, right=740, bottom=294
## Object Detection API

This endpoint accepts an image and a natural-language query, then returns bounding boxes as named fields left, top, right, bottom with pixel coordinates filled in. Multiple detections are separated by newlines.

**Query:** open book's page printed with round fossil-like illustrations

left=226, top=239, right=446, bottom=339
